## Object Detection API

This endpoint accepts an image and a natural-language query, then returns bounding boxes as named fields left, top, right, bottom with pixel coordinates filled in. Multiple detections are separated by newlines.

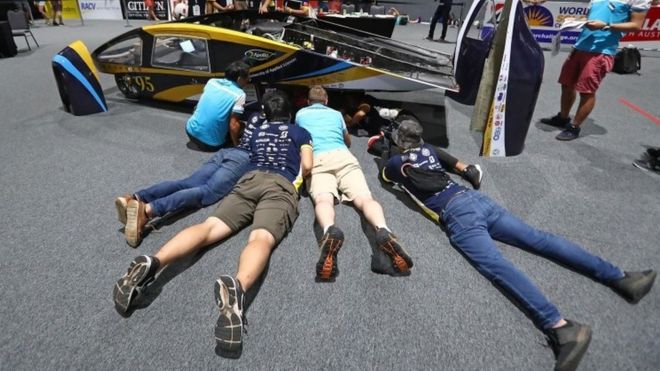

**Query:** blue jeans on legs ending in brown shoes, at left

left=135, top=148, right=250, bottom=216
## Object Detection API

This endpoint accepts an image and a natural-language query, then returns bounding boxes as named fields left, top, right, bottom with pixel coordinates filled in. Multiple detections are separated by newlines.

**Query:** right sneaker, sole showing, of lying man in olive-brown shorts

left=213, top=276, right=243, bottom=358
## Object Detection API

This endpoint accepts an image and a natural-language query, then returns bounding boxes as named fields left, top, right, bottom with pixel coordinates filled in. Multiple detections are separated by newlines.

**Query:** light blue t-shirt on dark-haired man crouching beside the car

left=186, top=79, right=245, bottom=146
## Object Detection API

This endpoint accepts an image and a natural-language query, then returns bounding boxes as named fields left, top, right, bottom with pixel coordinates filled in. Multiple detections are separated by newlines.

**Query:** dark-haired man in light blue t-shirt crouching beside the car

left=186, top=61, right=250, bottom=152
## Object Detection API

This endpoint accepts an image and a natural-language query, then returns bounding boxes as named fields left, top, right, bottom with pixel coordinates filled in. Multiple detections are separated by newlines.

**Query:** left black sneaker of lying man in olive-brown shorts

left=112, top=255, right=158, bottom=314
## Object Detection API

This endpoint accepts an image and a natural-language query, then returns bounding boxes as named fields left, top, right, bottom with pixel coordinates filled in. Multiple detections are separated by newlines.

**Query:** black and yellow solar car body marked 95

left=92, top=10, right=456, bottom=102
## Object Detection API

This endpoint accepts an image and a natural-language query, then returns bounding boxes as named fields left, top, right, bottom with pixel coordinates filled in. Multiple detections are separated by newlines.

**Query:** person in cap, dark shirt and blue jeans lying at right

left=379, top=119, right=656, bottom=370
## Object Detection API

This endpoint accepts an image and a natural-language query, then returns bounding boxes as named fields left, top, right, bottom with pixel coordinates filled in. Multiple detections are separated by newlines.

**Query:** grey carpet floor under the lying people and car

left=0, top=21, right=660, bottom=371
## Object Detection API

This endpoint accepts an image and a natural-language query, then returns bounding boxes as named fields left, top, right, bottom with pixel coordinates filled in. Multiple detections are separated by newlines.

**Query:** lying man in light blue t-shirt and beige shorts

left=296, top=85, right=413, bottom=281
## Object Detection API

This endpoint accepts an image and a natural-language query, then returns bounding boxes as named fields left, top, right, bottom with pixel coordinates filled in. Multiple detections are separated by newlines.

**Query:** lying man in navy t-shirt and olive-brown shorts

left=112, top=91, right=313, bottom=358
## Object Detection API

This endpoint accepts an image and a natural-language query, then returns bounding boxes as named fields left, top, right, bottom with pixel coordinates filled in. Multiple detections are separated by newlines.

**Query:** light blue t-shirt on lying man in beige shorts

left=296, top=103, right=347, bottom=155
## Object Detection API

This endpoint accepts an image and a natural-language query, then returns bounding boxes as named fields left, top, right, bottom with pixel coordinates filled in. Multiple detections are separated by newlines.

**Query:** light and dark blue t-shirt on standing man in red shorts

left=575, top=0, right=651, bottom=55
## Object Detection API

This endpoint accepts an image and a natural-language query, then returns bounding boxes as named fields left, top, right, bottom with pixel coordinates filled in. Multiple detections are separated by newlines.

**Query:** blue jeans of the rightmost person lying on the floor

left=442, top=191, right=623, bottom=329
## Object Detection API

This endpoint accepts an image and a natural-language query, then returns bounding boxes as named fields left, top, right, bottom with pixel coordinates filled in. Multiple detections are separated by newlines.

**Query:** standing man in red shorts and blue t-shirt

left=541, top=0, right=651, bottom=140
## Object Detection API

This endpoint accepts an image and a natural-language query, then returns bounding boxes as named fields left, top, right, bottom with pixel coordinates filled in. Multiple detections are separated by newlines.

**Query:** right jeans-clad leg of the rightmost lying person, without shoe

left=482, top=195, right=623, bottom=284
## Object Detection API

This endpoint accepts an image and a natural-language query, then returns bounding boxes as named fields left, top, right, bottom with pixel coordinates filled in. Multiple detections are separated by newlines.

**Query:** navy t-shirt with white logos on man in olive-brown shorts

left=248, top=121, right=312, bottom=189
